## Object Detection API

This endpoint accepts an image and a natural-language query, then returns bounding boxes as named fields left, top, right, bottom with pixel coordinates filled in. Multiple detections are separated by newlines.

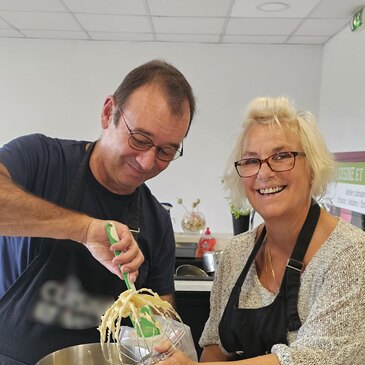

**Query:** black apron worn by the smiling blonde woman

left=219, top=202, right=320, bottom=360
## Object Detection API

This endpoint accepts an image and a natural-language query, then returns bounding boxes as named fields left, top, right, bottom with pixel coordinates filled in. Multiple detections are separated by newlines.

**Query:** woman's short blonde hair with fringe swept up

left=220, top=97, right=335, bottom=207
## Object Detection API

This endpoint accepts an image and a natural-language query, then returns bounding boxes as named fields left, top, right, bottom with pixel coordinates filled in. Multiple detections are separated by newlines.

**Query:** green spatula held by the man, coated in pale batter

left=105, top=222, right=160, bottom=337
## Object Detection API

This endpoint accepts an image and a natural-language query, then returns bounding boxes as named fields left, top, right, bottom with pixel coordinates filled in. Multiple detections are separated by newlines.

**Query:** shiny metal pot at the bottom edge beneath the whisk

left=36, top=343, right=147, bottom=365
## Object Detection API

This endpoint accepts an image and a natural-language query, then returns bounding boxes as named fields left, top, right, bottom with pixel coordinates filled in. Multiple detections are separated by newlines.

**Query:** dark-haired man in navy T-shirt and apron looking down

left=0, top=60, right=195, bottom=364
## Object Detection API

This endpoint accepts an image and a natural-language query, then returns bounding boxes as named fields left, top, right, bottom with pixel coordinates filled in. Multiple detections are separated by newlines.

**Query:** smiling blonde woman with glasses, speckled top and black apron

left=160, top=97, right=365, bottom=365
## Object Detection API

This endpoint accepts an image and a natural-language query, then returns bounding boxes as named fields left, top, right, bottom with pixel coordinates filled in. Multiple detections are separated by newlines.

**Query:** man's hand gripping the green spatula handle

left=84, top=219, right=144, bottom=282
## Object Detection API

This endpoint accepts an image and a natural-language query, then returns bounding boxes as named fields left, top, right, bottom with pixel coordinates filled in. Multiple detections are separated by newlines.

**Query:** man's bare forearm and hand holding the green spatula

left=0, top=163, right=144, bottom=281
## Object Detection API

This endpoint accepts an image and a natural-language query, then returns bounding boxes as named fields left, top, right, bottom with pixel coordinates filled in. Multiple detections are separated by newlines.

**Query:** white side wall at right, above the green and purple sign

left=320, top=27, right=365, bottom=152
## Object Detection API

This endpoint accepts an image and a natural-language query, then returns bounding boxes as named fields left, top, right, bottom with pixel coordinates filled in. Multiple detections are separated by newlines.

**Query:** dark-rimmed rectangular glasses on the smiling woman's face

left=234, top=152, right=305, bottom=177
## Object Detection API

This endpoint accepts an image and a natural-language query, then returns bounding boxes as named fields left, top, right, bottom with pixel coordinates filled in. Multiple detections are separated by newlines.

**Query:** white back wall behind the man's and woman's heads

left=0, top=39, right=323, bottom=233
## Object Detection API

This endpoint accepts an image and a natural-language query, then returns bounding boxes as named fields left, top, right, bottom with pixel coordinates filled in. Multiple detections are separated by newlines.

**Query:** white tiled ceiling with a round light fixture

left=0, top=0, right=365, bottom=44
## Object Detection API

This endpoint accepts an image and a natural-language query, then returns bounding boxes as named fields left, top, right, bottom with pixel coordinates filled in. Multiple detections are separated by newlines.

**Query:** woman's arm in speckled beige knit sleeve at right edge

left=272, top=228, right=365, bottom=365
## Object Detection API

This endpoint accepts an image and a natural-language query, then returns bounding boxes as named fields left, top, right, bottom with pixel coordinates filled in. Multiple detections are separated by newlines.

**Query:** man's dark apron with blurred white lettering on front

left=0, top=142, right=140, bottom=365
